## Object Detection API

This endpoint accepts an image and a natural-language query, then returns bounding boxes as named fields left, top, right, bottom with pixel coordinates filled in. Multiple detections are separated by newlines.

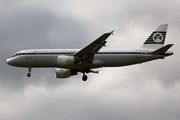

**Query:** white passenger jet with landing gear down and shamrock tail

left=6, top=24, right=173, bottom=81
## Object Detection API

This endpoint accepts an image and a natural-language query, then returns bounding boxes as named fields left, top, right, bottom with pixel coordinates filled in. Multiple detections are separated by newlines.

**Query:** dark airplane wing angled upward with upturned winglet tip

left=75, top=31, right=114, bottom=59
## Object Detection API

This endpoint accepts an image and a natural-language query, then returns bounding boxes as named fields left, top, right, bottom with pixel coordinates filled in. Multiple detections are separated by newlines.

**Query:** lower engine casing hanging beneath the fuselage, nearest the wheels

left=56, top=68, right=71, bottom=78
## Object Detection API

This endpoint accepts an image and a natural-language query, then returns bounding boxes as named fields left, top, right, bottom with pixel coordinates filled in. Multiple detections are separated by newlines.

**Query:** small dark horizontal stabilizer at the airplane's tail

left=152, top=44, right=174, bottom=55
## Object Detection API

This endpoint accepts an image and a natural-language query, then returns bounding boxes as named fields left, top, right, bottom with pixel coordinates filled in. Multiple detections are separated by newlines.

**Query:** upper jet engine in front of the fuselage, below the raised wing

left=57, top=56, right=81, bottom=67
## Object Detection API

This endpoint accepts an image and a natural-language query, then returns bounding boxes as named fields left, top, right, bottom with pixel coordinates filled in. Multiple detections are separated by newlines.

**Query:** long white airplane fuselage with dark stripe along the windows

left=6, top=49, right=173, bottom=69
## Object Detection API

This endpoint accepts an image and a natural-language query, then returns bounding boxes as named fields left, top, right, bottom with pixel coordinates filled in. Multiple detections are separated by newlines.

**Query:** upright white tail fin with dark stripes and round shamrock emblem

left=141, top=24, right=168, bottom=49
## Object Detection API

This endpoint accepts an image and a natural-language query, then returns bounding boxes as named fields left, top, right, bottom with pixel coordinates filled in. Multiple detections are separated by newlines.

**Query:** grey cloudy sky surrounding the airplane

left=0, top=0, right=180, bottom=120
